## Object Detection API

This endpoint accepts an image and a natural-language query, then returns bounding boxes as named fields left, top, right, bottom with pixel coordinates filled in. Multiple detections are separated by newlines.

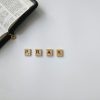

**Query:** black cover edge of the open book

left=0, top=0, right=38, bottom=48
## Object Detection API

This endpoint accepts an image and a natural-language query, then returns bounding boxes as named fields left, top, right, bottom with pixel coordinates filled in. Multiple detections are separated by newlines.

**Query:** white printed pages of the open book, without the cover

left=0, top=0, right=33, bottom=36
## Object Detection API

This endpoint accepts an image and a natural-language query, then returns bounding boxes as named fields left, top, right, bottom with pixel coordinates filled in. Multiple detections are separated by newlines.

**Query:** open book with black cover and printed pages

left=0, top=0, right=38, bottom=48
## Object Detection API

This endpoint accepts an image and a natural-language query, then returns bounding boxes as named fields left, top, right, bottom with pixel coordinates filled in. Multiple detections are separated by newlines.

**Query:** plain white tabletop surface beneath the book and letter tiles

left=0, top=0, right=100, bottom=100
